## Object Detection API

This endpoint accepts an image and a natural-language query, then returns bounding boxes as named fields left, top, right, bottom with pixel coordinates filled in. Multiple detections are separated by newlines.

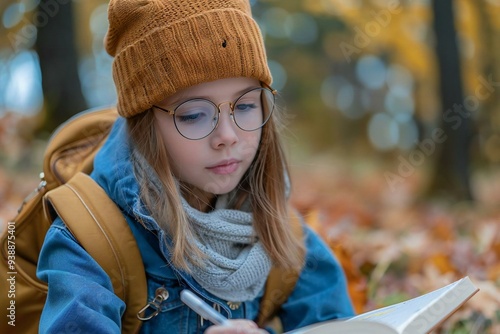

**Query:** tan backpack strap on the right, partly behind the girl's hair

left=256, top=210, right=305, bottom=327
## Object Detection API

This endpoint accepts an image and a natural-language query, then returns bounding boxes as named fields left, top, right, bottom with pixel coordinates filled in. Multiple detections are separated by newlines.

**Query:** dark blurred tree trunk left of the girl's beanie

left=36, top=0, right=87, bottom=132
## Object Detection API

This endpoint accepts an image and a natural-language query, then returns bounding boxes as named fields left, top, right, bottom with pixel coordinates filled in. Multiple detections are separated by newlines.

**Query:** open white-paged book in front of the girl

left=285, top=277, right=479, bottom=334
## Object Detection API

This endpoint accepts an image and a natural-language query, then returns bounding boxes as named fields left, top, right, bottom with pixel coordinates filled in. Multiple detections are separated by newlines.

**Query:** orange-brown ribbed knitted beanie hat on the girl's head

left=104, top=0, right=272, bottom=117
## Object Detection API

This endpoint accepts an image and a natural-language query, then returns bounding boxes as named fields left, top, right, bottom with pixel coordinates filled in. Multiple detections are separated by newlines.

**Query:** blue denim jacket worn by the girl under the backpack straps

left=37, top=118, right=354, bottom=334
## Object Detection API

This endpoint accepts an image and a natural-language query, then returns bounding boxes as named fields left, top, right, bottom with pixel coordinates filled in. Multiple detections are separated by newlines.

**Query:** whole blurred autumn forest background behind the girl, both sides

left=0, top=0, right=500, bottom=333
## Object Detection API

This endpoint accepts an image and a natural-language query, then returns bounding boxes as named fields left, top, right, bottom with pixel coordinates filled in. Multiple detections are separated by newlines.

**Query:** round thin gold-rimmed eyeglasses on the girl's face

left=153, top=87, right=277, bottom=140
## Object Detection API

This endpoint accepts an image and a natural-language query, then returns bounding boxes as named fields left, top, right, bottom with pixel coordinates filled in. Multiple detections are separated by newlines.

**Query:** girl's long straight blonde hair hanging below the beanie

left=127, top=106, right=304, bottom=271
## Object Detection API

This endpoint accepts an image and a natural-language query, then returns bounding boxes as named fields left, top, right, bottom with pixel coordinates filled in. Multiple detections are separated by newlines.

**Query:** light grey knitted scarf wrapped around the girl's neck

left=133, top=150, right=271, bottom=302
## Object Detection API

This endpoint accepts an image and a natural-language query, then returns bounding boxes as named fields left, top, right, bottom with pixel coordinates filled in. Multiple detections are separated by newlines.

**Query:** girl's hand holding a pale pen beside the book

left=181, top=290, right=267, bottom=334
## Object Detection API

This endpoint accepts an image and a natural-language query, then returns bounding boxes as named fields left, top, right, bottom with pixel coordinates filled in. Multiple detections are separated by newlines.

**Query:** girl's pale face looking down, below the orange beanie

left=153, top=78, right=262, bottom=195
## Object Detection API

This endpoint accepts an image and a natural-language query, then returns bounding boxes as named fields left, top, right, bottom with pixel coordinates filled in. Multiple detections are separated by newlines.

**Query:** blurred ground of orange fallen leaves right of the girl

left=292, top=155, right=500, bottom=334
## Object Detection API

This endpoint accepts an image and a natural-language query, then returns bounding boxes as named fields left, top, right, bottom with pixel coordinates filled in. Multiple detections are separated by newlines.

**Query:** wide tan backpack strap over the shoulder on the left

left=44, top=173, right=147, bottom=333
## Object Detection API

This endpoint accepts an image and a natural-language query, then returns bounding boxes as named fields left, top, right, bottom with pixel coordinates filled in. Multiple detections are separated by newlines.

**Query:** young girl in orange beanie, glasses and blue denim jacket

left=38, top=0, right=353, bottom=334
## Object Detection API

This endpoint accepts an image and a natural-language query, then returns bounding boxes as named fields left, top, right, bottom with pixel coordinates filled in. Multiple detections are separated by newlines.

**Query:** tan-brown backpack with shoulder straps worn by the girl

left=0, top=108, right=302, bottom=334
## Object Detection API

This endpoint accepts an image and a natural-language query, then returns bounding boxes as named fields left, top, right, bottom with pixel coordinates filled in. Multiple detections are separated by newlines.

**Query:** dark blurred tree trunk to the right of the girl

left=429, top=0, right=472, bottom=200
